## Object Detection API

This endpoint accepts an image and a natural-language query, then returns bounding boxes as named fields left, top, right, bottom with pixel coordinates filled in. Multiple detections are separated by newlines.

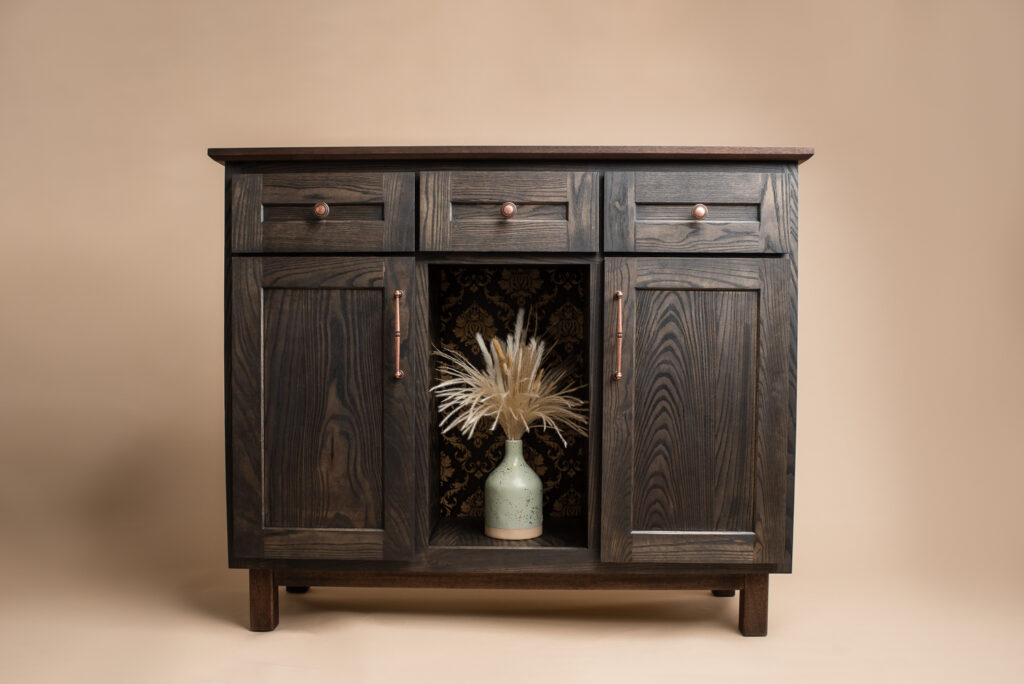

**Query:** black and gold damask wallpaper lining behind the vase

left=434, top=266, right=587, bottom=518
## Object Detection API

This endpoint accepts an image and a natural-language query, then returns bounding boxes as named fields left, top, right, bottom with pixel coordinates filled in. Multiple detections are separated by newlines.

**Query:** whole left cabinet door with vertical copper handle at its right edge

left=228, top=257, right=417, bottom=560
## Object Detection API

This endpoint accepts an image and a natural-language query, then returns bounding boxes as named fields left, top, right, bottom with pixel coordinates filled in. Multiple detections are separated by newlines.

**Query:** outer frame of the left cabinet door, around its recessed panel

left=227, top=256, right=419, bottom=564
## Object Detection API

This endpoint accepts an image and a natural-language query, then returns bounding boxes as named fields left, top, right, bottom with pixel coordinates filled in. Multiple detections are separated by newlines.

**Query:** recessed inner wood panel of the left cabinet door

left=263, top=288, right=384, bottom=528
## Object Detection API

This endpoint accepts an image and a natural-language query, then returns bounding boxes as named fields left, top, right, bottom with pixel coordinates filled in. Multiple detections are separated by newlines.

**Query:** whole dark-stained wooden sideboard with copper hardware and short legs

left=210, top=147, right=813, bottom=636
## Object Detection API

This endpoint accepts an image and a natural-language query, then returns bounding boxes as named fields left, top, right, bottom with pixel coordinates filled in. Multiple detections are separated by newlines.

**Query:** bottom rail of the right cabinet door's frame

left=633, top=531, right=757, bottom=563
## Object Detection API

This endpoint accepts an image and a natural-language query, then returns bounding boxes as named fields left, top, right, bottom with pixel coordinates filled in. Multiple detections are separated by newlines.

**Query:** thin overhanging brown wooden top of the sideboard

left=208, top=145, right=814, bottom=164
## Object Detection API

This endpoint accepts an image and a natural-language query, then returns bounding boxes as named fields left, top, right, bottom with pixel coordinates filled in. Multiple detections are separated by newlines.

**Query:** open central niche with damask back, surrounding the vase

left=428, top=259, right=597, bottom=549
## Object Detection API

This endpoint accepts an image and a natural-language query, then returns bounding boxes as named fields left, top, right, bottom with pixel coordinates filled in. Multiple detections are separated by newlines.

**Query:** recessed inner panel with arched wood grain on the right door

left=633, top=290, right=758, bottom=530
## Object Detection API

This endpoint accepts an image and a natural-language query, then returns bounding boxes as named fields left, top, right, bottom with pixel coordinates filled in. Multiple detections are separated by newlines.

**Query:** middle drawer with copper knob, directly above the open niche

left=420, top=171, right=598, bottom=252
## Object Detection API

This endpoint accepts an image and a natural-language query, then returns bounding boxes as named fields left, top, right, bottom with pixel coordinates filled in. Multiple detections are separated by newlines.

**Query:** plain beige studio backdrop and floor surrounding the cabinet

left=0, top=0, right=1024, bottom=682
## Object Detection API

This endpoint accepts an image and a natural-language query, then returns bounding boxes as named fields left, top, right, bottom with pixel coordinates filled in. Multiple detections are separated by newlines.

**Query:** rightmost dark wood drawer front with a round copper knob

left=604, top=170, right=796, bottom=253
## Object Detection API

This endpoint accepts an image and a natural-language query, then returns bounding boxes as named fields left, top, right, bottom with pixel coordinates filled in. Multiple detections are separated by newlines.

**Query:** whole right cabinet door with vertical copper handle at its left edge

left=601, top=257, right=796, bottom=571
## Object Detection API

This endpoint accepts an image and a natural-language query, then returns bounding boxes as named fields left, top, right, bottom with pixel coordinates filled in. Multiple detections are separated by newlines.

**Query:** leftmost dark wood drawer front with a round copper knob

left=231, top=172, right=416, bottom=252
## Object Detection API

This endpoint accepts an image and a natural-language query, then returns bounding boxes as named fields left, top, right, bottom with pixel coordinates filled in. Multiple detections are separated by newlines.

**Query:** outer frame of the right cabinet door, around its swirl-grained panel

left=601, top=257, right=796, bottom=571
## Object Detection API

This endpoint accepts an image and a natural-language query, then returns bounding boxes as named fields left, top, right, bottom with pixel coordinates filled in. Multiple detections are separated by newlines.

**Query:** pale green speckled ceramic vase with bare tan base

left=483, top=439, right=544, bottom=540
